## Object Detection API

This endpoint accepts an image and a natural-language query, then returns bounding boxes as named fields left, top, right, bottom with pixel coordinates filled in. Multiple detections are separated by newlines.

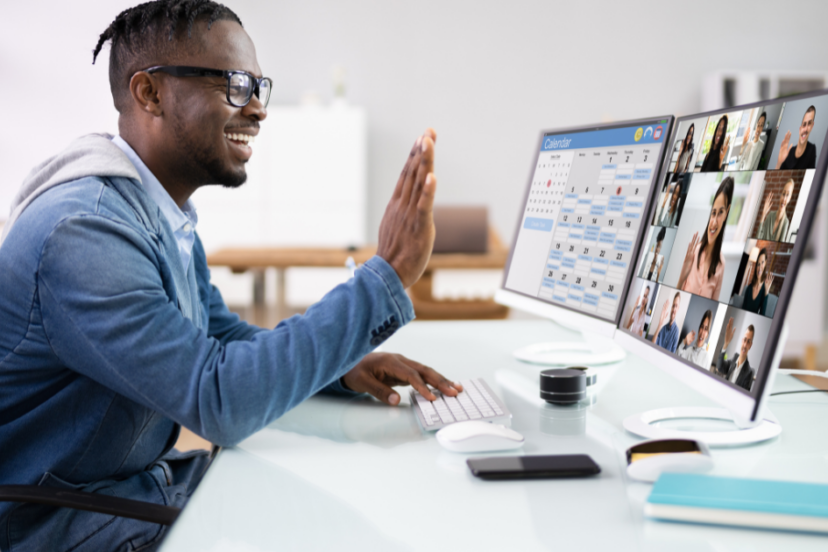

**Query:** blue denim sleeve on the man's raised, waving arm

left=38, top=215, right=414, bottom=445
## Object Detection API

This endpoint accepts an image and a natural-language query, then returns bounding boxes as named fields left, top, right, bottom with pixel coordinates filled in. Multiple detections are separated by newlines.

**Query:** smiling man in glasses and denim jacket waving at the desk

left=0, top=0, right=461, bottom=552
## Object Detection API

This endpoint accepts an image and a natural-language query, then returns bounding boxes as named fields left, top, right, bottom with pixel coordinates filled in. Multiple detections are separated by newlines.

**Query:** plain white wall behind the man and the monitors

left=0, top=0, right=828, bottom=244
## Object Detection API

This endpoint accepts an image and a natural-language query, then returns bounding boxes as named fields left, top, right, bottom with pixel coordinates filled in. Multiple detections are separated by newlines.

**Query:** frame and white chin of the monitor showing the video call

left=615, top=89, right=828, bottom=423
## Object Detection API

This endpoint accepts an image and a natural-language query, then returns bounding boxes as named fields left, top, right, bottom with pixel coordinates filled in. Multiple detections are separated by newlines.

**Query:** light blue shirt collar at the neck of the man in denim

left=112, top=136, right=198, bottom=273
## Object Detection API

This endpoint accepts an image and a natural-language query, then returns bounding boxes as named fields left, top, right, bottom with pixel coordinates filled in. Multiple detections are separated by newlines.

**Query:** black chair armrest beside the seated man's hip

left=0, top=485, right=181, bottom=525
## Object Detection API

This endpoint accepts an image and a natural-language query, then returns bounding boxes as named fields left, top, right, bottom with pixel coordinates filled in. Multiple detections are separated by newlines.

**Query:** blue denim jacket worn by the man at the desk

left=0, top=135, right=414, bottom=549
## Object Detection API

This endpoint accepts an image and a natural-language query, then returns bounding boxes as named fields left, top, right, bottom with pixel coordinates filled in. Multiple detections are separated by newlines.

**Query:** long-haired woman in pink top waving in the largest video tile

left=678, top=176, right=735, bottom=301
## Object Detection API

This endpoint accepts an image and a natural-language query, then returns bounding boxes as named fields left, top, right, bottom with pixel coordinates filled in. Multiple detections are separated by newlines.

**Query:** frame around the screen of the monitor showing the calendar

left=502, top=115, right=676, bottom=328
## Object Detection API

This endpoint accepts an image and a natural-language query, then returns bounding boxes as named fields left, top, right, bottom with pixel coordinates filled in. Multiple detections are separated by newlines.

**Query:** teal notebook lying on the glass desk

left=644, top=473, right=828, bottom=533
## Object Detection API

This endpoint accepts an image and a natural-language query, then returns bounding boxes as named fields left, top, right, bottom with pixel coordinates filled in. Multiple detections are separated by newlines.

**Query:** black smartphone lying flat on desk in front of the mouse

left=466, top=454, right=601, bottom=479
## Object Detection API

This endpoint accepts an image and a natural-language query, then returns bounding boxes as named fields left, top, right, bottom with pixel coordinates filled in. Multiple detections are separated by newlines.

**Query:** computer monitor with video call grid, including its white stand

left=615, top=91, right=828, bottom=445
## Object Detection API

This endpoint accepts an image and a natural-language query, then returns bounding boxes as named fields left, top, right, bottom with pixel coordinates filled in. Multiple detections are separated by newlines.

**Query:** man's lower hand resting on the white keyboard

left=342, top=353, right=463, bottom=406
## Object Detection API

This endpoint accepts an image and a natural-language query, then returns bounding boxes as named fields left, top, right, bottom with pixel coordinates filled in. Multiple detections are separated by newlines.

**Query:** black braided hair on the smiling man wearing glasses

left=92, top=0, right=242, bottom=113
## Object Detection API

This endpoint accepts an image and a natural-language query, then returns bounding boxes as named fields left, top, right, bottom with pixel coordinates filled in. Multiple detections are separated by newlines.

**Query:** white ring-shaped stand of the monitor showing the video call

left=624, top=324, right=788, bottom=447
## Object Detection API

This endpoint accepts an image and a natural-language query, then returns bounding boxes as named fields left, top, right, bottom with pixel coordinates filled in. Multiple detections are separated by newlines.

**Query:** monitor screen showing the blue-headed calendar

left=503, top=117, right=672, bottom=324
